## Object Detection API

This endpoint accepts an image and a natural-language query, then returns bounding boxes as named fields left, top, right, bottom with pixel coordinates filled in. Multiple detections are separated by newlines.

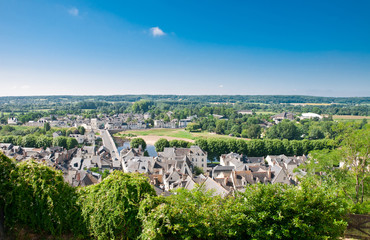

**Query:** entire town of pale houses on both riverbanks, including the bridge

left=0, top=111, right=322, bottom=196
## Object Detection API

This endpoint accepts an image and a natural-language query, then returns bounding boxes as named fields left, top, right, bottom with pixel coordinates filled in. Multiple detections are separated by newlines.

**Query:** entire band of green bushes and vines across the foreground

left=0, top=155, right=354, bottom=239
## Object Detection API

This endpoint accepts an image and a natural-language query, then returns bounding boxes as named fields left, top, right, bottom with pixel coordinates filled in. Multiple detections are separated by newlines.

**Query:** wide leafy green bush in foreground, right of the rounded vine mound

left=139, top=181, right=347, bottom=239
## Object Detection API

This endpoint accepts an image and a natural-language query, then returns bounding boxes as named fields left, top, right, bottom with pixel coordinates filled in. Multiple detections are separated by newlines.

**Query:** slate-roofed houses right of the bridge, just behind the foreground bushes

left=121, top=146, right=306, bottom=196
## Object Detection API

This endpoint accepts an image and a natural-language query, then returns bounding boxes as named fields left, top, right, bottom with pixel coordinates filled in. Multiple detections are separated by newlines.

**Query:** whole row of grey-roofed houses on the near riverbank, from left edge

left=0, top=138, right=306, bottom=196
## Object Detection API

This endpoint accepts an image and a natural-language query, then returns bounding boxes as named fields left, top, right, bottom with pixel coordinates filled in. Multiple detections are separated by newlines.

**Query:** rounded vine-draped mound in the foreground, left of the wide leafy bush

left=79, top=171, right=155, bottom=239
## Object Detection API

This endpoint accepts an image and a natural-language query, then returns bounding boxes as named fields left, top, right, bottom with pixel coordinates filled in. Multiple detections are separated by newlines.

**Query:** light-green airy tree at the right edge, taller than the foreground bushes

left=301, top=127, right=370, bottom=212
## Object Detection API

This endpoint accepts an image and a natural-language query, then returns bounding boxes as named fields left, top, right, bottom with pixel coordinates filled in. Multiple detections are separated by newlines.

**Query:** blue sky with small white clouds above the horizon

left=0, top=0, right=370, bottom=96
